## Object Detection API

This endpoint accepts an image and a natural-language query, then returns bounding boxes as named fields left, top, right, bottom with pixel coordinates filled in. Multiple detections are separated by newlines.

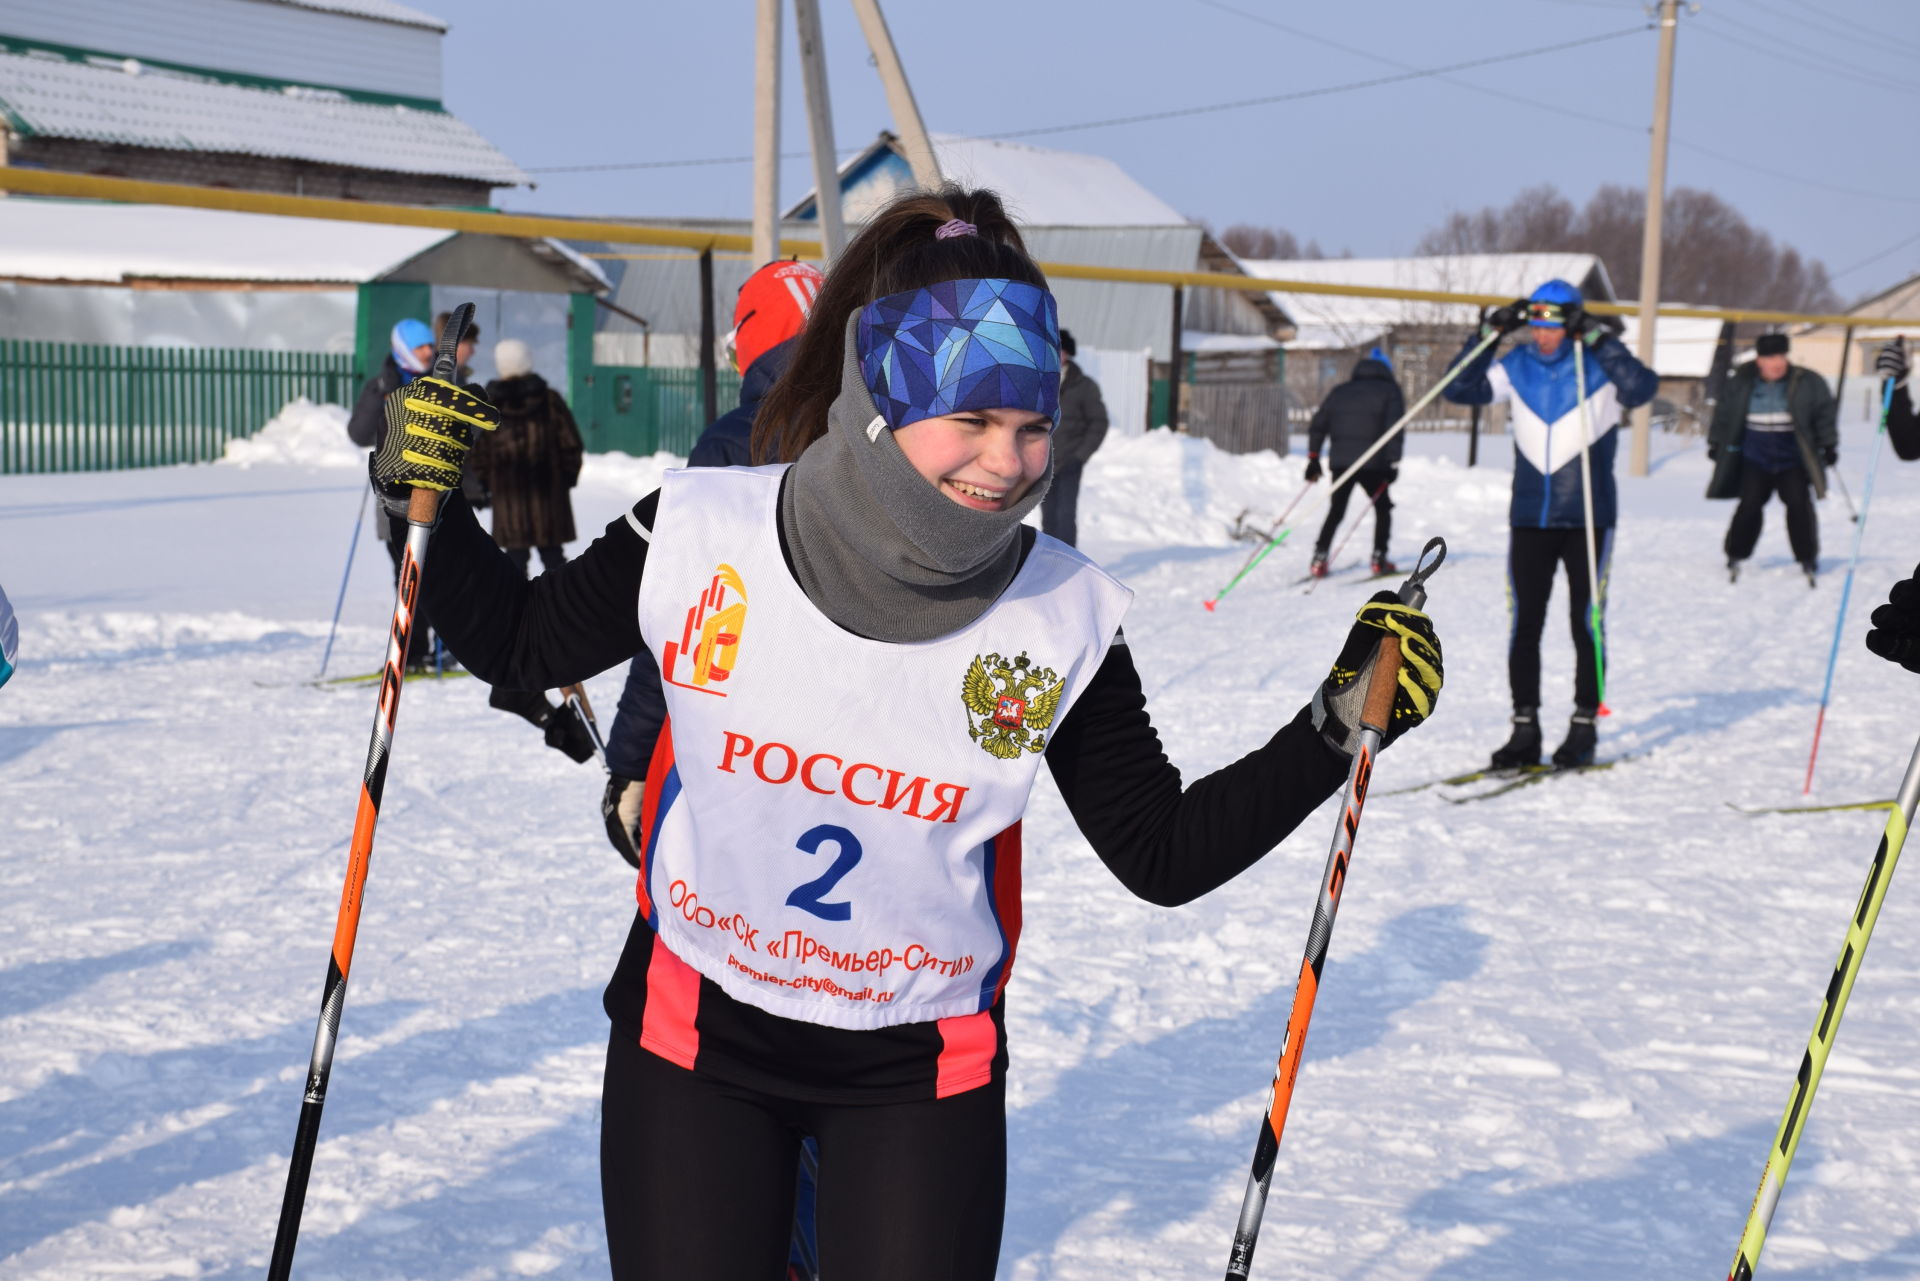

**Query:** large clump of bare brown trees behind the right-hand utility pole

left=1415, top=182, right=1839, bottom=311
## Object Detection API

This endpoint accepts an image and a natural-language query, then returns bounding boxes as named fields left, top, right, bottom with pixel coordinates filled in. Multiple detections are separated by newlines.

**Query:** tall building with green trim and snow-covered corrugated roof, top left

left=0, top=0, right=526, bottom=205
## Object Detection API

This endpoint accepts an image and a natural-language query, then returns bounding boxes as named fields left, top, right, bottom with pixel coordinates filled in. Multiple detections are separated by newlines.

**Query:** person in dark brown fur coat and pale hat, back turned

left=467, top=338, right=580, bottom=570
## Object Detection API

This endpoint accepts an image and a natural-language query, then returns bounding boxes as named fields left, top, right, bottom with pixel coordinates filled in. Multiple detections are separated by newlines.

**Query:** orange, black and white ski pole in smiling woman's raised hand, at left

left=267, top=303, right=474, bottom=1281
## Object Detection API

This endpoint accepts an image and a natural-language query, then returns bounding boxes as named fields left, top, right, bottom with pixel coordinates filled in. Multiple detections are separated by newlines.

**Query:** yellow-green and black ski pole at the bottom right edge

left=1726, top=725, right=1920, bottom=1281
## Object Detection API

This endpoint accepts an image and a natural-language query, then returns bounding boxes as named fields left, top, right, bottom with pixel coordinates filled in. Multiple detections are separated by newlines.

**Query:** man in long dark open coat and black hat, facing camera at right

left=1707, top=334, right=1839, bottom=586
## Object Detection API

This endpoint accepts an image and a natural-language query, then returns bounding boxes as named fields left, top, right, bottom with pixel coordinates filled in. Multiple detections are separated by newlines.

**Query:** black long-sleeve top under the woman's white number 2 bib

left=422, top=483, right=1348, bottom=1102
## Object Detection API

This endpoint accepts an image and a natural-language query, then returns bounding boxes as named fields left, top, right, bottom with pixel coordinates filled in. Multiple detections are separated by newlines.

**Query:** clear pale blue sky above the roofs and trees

left=441, top=0, right=1920, bottom=298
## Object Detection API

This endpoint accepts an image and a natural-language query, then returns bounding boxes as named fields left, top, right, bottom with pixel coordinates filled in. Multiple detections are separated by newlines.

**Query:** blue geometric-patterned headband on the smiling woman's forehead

left=854, top=280, right=1060, bottom=430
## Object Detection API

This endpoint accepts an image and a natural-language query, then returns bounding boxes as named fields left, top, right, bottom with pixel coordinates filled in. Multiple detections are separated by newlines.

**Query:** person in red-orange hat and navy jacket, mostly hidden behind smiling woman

left=601, top=261, right=824, bottom=866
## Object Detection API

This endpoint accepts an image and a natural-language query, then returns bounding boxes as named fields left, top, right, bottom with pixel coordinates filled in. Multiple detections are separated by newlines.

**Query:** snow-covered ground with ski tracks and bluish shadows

left=0, top=411, right=1920, bottom=1281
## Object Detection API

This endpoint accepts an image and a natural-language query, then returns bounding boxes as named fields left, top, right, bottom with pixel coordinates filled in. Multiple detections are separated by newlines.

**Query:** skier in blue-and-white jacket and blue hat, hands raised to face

left=1444, top=280, right=1659, bottom=770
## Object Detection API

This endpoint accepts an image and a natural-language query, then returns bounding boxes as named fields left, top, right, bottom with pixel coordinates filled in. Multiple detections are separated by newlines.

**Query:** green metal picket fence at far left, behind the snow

left=0, top=338, right=357, bottom=474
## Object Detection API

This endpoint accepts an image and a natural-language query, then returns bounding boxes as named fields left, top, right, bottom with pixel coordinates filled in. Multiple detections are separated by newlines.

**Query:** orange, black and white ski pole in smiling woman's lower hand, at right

left=1227, top=538, right=1446, bottom=1281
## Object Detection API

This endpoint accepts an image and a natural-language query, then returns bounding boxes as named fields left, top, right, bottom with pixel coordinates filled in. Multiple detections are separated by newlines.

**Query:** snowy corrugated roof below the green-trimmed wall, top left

left=0, top=54, right=528, bottom=186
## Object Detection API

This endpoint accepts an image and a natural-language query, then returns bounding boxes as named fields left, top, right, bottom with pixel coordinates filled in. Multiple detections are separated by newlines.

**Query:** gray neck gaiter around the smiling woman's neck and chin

left=780, top=317, right=1052, bottom=641
